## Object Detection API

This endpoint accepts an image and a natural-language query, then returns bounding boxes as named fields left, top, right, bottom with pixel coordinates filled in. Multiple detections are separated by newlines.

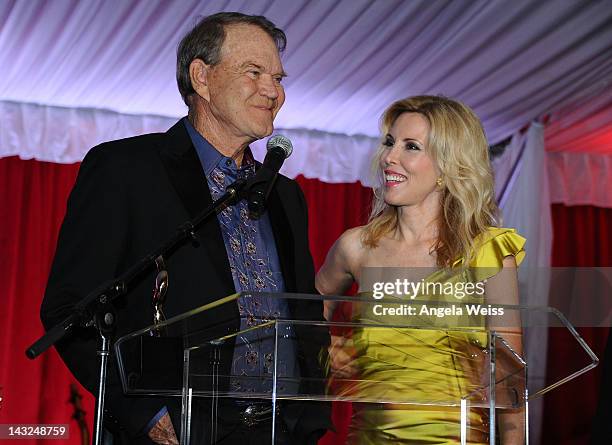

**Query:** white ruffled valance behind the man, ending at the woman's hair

left=0, top=101, right=378, bottom=181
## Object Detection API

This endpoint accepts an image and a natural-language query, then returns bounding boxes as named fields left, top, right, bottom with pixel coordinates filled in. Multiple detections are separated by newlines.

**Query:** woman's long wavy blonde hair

left=362, top=96, right=499, bottom=267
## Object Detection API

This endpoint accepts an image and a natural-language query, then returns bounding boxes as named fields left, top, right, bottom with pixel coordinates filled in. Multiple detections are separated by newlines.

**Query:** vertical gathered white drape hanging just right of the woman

left=493, top=122, right=552, bottom=443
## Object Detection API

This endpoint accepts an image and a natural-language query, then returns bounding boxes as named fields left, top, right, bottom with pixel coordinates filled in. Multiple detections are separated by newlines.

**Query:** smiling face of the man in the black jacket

left=207, top=24, right=285, bottom=143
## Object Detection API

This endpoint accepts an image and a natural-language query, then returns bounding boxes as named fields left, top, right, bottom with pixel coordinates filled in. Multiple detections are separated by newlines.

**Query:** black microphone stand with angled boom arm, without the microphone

left=26, top=176, right=247, bottom=445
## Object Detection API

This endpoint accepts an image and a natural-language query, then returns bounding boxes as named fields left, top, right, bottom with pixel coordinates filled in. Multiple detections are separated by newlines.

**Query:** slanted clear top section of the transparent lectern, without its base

left=115, top=293, right=597, bottom=408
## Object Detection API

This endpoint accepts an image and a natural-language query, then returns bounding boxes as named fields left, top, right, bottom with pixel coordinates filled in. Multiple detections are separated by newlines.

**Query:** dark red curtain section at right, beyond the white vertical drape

left=543, top=204, right=612, bottom=445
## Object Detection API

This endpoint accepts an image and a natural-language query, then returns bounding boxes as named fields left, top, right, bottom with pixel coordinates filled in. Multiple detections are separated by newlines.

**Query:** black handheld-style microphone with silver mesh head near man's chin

left=248, top=134, right=293, bottom=218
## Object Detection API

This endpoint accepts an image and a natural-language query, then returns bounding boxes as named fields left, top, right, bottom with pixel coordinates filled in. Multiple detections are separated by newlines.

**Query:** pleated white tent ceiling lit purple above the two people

left=0, top=0, right=612, bottom=142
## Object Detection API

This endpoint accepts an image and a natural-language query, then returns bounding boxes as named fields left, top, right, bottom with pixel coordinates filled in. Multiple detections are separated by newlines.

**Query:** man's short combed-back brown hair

left=176, top=12, right=287, bottom=107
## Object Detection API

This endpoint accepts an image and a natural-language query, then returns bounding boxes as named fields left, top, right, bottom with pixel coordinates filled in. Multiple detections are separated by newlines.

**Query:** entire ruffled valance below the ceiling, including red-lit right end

left=0, top=101, right=612, bottom=212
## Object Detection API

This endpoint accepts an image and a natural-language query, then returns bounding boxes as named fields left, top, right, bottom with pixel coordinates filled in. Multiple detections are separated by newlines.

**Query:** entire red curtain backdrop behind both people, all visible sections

left=0, top=157, right=612, bottom=445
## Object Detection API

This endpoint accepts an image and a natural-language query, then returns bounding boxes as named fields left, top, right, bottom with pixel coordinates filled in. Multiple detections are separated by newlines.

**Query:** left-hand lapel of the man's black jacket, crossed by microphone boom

left=159, top=121, right=234, bottom=289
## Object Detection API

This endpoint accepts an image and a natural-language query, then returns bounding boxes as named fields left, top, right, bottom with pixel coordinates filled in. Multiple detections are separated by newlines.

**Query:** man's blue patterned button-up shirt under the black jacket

left=183, top=118, right=298, bottom=392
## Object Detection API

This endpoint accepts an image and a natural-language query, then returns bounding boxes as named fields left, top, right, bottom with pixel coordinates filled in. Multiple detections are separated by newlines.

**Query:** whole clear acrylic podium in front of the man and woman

left=115, top=293, right=598, bottom=444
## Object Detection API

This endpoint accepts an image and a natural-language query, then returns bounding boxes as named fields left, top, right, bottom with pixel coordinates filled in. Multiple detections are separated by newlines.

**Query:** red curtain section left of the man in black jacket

left=0, top=157, right=93, bottom=444
